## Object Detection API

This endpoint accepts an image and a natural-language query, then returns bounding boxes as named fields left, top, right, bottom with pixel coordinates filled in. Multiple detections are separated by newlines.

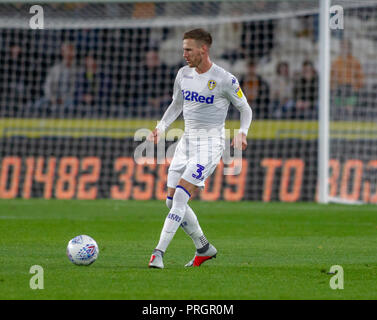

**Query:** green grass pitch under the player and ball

left=0, top=200, right=377, bottom=300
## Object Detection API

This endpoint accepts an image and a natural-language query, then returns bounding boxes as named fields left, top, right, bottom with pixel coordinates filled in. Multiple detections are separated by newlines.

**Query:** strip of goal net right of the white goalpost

left=329, top=1, right=377, bottom=203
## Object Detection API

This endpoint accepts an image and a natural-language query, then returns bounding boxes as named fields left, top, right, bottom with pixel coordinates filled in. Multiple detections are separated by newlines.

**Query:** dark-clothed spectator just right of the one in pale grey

left=75, top=54, right=111, bottom=114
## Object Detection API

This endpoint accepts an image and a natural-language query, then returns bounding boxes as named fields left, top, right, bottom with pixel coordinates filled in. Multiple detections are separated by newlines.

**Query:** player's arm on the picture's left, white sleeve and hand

left=147, top=69, right=183, bottom=143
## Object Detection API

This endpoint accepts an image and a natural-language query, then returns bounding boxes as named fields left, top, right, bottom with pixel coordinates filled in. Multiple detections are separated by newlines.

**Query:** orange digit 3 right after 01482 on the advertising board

left=110, top=157, right=135, bottom=199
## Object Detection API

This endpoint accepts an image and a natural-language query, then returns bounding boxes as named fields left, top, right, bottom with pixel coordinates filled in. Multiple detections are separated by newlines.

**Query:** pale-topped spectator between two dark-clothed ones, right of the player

left=271, top=62, right=294, bottom=119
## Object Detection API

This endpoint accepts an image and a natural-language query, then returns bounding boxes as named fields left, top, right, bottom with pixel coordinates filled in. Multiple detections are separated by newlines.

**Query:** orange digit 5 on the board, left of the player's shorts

left=133, top=158, right=156, bottom=200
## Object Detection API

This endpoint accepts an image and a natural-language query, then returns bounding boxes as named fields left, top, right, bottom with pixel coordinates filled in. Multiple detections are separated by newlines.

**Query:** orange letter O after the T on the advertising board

left=280, top=158, right=305, bottom=202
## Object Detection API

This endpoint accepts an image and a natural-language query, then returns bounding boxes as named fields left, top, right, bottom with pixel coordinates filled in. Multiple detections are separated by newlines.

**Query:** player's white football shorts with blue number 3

left=167, top=136, right=225, bottom=188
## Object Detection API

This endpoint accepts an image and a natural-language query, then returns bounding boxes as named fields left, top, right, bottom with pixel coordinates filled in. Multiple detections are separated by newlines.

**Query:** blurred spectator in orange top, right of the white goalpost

left=331, top=39, right=364, bottom=115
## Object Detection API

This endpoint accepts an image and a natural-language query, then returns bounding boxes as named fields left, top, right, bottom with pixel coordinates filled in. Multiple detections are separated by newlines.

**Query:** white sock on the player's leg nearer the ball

left=156, top=185, right=190, bottom=252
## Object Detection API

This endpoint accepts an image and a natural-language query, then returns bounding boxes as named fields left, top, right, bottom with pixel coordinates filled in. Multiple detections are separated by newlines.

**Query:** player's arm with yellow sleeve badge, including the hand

left=224, top=76, right=253, bottom=150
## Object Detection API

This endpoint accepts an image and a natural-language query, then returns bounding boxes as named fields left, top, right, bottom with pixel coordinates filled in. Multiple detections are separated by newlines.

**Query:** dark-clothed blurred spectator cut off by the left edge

left=0, top=41, right=30, bottom=116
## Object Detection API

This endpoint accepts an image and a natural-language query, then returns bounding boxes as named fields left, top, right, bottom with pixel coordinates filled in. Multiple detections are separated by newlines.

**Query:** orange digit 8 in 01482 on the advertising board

left=55, top=157, right=79, bottom=199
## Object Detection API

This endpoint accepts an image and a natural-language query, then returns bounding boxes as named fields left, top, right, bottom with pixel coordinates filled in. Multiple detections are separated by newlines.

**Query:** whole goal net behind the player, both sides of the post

left=0, top=0, right=377, bottom=203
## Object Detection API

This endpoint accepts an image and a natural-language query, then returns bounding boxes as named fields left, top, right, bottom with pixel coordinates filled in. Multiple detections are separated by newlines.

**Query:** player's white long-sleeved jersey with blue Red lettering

left=157, top=63, right=251, bottom=138
